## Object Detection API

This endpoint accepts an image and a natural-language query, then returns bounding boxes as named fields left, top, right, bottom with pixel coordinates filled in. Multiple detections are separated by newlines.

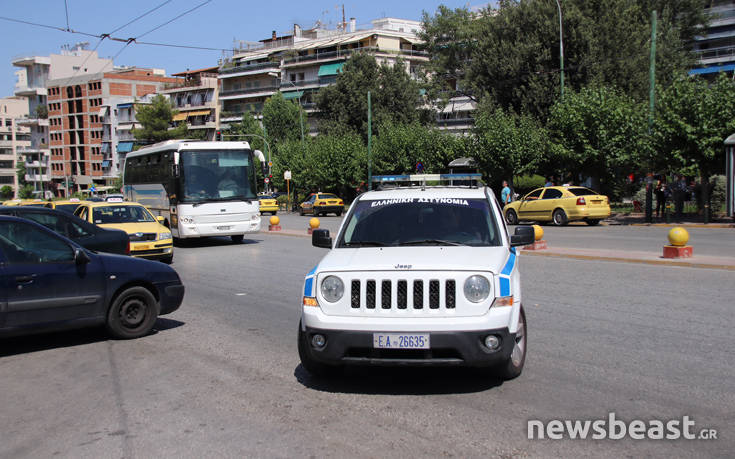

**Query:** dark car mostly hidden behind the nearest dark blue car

left=0, top=206, right=130, bottom=255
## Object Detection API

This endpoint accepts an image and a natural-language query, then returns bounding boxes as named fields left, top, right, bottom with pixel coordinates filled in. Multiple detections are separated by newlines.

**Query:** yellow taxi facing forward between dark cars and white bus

left=74, top=200, right=174, bottom=263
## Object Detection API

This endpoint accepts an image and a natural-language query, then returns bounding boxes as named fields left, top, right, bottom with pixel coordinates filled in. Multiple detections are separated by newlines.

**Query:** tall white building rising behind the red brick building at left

left=12, top=43, right=112, bottom=194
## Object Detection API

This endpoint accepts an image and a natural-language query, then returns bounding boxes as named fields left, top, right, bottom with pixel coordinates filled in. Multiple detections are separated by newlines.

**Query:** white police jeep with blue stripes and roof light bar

left=298, top=174, right=534, bottom=379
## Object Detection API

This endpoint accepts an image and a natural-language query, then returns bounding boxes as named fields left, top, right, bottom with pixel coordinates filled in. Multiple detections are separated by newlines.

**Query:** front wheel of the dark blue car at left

left=107, top=287, right=159, bottom=339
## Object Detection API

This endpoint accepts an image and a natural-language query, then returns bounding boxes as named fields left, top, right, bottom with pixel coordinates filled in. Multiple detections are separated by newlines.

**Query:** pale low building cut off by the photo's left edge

left=0, top=97, right=31, bottom=197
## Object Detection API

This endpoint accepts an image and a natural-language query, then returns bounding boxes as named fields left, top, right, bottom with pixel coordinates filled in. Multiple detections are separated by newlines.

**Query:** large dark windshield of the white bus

left=181, top=150, right=256, bottom=202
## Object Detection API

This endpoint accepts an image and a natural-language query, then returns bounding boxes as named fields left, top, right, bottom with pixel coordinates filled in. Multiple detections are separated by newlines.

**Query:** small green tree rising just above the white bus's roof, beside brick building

left=133, top=94, right=188, bottom=143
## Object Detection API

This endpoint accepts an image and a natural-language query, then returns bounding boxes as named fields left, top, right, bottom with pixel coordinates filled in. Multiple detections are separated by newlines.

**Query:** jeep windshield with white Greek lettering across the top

left=337, top=198, right=502, bottom=248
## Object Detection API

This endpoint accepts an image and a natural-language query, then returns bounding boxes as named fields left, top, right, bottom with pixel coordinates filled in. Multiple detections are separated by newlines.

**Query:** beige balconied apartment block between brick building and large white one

left=161, top=67, right=220, bottom=140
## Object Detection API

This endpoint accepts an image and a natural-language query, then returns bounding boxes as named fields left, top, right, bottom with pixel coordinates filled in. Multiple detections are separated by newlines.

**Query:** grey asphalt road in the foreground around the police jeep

left=0, top=235, right=735, bottom=458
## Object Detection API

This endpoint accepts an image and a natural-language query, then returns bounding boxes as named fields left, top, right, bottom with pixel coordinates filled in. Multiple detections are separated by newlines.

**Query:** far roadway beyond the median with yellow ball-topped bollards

left=270, top=213, right=735, bottom=259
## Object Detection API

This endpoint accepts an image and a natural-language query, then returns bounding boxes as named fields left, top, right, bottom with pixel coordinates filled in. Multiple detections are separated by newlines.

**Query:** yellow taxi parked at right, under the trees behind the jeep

left=503, top=186, right=610, bottom=226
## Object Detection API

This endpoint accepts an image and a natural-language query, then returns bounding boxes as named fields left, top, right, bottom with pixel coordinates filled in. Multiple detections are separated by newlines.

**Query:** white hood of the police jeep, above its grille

left=317, top=246, right=508, bottom=274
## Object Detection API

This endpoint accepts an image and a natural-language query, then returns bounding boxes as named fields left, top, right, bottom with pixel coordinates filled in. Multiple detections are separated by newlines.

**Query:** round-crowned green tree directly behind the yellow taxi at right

left=547, top=87, right=650, bottom=193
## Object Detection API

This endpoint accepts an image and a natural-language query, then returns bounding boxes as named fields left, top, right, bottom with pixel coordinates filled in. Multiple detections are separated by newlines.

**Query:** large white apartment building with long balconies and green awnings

left=219, top=18, right=429, bottom=129
